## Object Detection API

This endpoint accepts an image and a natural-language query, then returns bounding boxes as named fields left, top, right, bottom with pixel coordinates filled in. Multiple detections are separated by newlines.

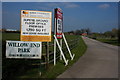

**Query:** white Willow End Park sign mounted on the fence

left=6, top=41, right=42, bottom=59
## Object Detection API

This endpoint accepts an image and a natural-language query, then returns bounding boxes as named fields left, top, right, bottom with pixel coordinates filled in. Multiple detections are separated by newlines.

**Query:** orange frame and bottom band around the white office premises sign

left=20, top=10, right=52, bottom=42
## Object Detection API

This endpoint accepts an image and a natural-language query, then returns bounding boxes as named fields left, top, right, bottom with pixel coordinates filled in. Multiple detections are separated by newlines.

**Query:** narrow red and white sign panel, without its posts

left=55, top=8, right=63, bottom=39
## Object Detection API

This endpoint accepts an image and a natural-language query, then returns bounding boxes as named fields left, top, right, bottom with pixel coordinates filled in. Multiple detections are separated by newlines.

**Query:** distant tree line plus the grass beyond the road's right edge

left=68, top=28, right=120, bottom=46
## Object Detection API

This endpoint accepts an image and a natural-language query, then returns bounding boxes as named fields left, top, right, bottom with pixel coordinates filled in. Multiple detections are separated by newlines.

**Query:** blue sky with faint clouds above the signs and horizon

left=2, top=2, right=118, bottom=32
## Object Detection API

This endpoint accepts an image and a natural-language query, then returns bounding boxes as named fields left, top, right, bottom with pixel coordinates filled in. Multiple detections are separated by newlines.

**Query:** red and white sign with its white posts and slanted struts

left=54, top=8, right=75, bottom=66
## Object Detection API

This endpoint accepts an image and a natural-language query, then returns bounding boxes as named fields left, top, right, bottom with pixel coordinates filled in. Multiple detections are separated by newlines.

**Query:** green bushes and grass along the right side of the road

left=88, top=28, right=120, bottom=46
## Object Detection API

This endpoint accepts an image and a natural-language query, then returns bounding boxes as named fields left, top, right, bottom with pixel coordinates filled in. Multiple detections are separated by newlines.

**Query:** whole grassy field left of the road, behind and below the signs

left=2, top=33, right=87, bottom=80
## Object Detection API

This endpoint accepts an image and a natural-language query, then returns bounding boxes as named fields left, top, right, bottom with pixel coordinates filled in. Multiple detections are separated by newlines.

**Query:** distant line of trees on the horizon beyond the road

left=68, top=28, right=120, bottom=39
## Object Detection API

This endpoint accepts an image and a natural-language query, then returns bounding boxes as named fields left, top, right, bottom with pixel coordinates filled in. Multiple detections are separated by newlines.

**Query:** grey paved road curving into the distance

left=57, top=37, right=118, bottom=78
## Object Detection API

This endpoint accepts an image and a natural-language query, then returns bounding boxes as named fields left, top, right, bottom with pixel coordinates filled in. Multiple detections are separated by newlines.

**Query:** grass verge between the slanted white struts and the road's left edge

left=39, top=37, right=87, bottom=78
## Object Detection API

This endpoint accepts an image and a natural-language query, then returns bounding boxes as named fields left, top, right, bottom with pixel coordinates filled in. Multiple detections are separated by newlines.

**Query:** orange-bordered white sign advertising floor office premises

left=21, top=10, right=52, bottom=42
